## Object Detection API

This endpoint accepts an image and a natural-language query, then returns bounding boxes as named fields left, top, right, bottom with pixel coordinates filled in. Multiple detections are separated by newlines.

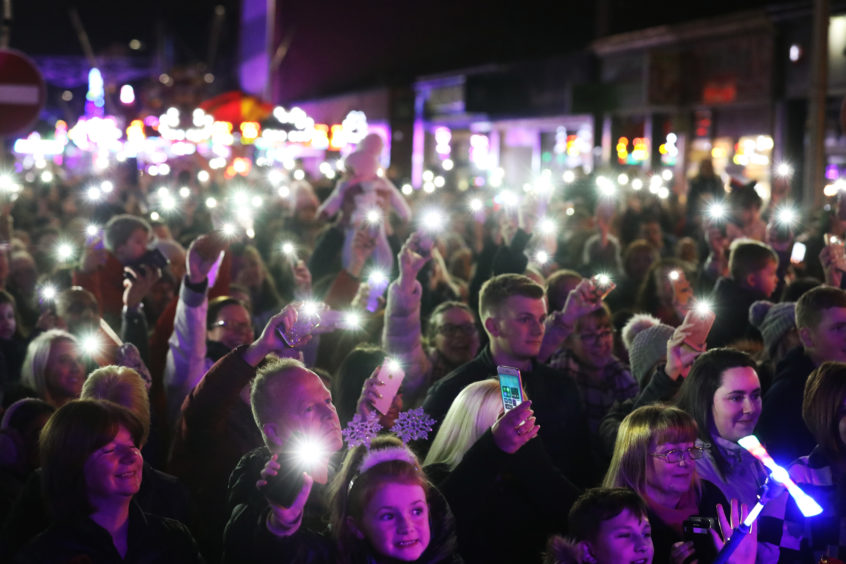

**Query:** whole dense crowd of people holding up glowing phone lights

left=0, top=139, right=846, bottom=564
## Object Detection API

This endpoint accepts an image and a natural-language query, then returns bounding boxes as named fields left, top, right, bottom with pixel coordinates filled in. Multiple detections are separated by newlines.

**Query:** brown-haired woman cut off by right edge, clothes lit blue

left=772, top=362, right=846, bottom=563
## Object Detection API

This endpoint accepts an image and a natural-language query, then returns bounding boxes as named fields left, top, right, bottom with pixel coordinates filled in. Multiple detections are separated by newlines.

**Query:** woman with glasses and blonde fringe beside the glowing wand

left=602, top=405, right=729, bottom=564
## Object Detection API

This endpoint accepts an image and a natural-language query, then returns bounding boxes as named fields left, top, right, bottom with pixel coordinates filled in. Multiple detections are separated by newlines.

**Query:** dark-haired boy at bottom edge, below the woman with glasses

left=544, top=488, right=654, bottom=564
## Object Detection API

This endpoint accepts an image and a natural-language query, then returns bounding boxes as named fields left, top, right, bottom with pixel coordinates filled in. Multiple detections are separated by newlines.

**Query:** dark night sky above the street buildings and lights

left=11, top=0, right=788, bottom=99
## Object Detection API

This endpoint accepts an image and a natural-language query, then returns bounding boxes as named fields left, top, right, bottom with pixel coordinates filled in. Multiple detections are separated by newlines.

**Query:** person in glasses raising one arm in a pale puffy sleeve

left=382, top=232, right=479, bottom=407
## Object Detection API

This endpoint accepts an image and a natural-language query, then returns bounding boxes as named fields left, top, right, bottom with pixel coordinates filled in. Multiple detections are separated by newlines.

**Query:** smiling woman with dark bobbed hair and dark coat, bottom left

left=16, top=400, right=203, bottom=563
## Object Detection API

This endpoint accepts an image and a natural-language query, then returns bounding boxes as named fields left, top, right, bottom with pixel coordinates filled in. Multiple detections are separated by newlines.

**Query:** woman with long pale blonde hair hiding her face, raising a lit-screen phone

left=424, top=380, right=579, bottom=564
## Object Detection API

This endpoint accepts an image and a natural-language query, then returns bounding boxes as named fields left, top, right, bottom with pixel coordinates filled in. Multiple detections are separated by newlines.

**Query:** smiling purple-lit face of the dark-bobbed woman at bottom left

left=83, top=425, right=144, bottom=507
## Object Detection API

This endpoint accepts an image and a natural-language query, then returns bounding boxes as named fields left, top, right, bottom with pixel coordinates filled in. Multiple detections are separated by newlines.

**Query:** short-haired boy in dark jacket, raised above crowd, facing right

left=708, top=239, right=779, bottom=349
